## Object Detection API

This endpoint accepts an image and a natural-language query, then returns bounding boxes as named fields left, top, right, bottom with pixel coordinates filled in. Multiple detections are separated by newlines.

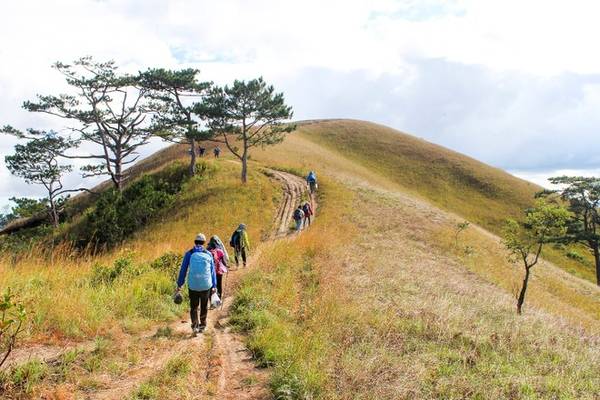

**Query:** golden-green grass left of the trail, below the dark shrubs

left=0, top=161, right=280, bottom=342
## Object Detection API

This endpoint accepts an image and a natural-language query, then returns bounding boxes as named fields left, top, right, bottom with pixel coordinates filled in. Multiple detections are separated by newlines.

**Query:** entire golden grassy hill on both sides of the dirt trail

left=0, top=120, right=600, bottom=399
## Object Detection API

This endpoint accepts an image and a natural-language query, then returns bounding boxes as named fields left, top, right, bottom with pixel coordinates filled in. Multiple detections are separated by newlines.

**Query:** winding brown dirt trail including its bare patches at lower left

left=5, top=170, right=316, bottom=400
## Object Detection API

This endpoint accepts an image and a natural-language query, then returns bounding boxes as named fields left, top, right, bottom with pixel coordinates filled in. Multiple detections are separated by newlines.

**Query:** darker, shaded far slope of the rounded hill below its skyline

left=264, top=120, right=541, bottom=232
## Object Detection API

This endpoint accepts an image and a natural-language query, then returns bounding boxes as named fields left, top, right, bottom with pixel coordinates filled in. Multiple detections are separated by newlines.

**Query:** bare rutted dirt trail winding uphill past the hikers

left=86, top=170, right=314, bottom=400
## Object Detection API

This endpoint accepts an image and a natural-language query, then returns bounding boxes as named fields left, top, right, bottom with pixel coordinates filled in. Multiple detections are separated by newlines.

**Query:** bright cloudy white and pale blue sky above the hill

left=0, top=0, right=600, bottom=211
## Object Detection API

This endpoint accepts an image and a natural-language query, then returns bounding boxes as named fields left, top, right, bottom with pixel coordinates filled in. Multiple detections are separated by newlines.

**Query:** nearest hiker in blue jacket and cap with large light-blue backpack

left=177, top=233, right=217, bottom=336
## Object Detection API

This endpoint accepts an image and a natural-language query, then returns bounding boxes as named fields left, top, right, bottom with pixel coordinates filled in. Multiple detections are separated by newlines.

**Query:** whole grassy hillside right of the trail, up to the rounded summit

left=241, top=121, right=600, bottom=399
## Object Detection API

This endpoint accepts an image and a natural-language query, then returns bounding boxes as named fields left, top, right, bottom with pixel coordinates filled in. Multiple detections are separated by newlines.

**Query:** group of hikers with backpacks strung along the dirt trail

left=173, top=170, right=317, bottom=336
